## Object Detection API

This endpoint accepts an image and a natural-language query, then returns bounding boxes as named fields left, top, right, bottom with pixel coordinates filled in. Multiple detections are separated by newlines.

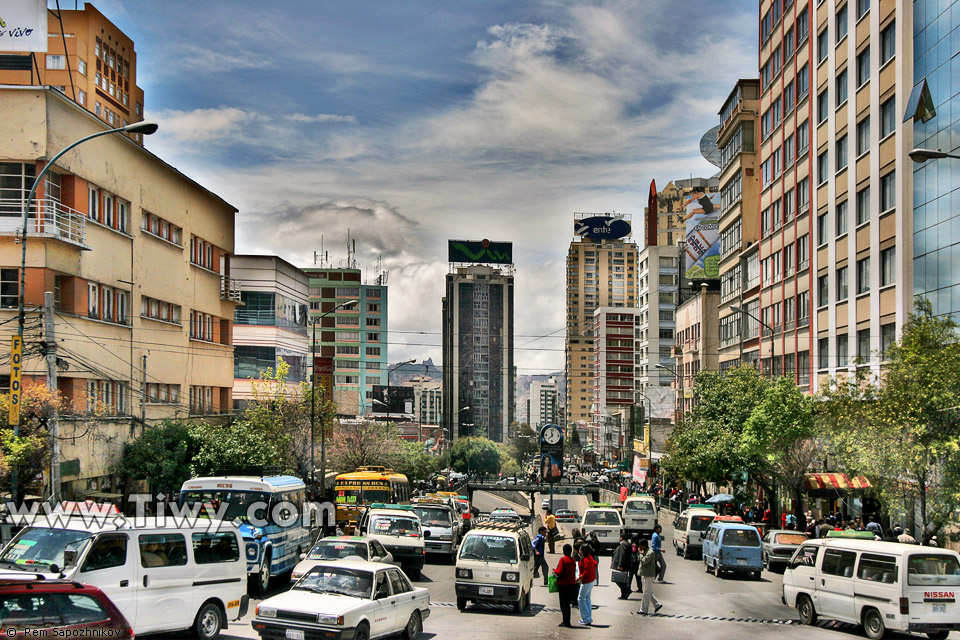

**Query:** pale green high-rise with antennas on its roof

left=304, top=258, right=389, bottom=416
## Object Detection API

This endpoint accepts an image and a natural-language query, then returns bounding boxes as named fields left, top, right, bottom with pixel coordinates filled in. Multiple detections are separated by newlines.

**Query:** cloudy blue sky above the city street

left=84, top=0, right=758, bottom=375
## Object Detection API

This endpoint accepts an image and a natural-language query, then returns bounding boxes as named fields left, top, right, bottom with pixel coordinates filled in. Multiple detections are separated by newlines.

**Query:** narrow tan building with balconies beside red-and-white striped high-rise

left=716, top=79, right=768, bottom=371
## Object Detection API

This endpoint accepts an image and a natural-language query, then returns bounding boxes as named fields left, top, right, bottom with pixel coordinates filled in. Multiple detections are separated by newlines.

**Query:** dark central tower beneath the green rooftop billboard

left=443, top=264, right=516, bottom=442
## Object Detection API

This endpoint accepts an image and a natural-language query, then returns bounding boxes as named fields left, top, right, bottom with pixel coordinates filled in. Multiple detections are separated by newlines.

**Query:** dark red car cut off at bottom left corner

left=0, top=574, right=133, bottom=638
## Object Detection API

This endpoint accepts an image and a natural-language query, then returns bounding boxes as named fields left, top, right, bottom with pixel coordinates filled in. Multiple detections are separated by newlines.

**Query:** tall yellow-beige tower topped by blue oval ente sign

left=564, top=218, right=637, bottom=427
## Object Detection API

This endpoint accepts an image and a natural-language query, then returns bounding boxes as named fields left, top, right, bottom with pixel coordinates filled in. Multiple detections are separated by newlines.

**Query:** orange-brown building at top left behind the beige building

left=0, top=3, right=143, bottom=142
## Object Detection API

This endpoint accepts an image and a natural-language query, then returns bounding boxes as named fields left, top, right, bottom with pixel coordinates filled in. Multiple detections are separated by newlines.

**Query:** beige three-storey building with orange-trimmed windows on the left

left=0, top=87, right=238, bottom=498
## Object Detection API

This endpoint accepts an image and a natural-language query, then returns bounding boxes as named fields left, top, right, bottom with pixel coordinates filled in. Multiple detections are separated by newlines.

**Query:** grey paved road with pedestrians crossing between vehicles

left=195, top=508, right=936, bottom=640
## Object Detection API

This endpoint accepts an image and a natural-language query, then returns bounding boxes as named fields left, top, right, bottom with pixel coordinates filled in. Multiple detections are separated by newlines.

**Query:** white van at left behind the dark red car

left=0, top=514, right=249, bottom=640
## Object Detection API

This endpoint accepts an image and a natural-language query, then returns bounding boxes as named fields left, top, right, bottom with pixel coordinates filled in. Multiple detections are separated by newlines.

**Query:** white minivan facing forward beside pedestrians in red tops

left=456, top=520, right=534, bottom=613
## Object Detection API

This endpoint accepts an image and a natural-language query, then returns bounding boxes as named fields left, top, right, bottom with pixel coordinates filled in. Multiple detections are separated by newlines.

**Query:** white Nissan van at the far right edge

left=782, top=537, right=960, bottom=639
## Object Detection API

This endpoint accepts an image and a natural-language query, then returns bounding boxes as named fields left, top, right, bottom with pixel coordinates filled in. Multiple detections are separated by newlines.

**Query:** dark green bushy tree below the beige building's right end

left=115, top=420, right=198, bottom=496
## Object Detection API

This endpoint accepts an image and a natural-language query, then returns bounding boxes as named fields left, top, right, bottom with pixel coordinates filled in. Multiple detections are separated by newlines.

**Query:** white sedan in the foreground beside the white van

left=253, top=560, right=430, bottom=640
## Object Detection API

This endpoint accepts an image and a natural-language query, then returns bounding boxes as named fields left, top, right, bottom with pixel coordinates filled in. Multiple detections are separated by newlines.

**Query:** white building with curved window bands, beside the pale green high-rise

left=231, top=255, right=310, bottom=409
